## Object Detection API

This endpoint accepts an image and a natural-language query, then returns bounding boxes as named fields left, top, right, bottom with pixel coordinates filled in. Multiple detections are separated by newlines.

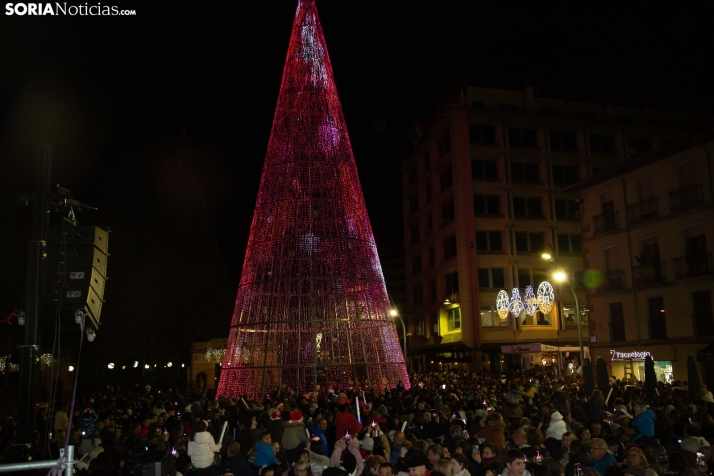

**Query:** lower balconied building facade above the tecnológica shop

left=567, top=132, right=714, bottom=382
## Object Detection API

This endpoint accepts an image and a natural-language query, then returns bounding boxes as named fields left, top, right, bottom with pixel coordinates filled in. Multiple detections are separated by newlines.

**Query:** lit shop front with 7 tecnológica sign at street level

left=593, top=345, right=672, bottom=383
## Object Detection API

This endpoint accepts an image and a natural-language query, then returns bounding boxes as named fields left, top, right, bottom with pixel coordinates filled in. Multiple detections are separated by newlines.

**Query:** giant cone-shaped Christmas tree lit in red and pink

left=218, top=0, right=409, bottom=398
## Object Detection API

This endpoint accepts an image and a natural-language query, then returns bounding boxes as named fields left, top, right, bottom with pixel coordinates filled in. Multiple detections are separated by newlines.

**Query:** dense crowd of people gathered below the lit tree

left=0, top=368, right=714, bottom=476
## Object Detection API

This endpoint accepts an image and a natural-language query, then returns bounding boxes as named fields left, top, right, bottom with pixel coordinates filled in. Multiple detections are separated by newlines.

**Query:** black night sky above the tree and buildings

left=0, top=0, right=714, bottom=360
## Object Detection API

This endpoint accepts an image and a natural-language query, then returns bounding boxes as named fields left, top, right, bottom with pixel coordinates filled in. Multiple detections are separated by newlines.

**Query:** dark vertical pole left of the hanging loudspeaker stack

left=17, top=144, right=52, bottom=445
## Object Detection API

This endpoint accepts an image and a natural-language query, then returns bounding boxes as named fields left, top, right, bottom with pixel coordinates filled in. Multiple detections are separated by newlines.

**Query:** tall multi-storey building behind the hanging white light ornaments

left=400, top=87, right=711, bottom=376
